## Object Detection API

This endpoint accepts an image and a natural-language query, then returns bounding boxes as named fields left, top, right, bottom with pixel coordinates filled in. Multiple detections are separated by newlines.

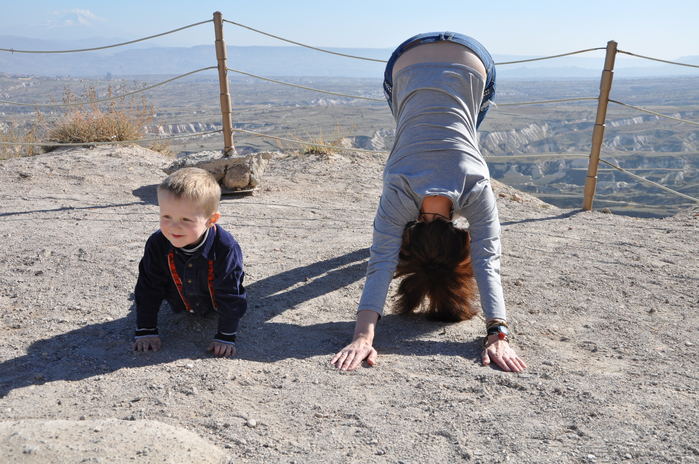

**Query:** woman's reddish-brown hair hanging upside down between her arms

left=394, top=219, right=478, bottom=322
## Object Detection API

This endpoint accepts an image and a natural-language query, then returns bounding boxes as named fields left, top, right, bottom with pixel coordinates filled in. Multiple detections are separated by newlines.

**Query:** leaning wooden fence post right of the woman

left=583, top=40, right=617, bottom=211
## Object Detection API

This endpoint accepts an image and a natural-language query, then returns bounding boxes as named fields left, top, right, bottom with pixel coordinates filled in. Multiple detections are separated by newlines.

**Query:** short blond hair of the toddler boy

left=158, top=168, right=221, bottom=216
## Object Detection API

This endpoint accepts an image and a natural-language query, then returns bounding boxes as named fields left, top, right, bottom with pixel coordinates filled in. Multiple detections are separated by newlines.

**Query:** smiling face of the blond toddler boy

left=158, top=192, right=221, bottom=248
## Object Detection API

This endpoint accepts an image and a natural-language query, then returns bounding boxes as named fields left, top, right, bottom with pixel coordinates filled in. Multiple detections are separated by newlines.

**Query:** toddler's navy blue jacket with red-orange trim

left=135, top=226, right=247, bottom=334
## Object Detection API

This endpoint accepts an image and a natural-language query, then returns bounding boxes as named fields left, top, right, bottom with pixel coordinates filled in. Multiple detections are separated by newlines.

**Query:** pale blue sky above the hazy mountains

left=0, top=0, right=699, bottom=60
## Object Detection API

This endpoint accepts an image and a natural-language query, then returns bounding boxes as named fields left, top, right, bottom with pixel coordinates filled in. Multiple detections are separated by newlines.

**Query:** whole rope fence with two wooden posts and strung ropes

left=0, top=12, right=699, bottom=209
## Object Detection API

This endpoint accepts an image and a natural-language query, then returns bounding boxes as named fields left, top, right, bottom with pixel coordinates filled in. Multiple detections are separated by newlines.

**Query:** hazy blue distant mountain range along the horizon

left=0, top=36, right=699, bottom=80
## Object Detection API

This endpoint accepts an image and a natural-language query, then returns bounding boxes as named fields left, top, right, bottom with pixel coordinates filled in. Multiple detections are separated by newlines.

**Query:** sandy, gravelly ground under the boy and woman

left=0, top=148, right=699, bottom=463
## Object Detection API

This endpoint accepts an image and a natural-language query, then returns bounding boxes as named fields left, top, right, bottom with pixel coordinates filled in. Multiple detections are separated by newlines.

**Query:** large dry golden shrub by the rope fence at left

left=37, top=82, right=154, bottom=147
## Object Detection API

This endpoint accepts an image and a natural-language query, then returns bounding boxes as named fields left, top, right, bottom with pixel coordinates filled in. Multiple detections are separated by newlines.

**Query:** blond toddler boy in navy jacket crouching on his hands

left=133, top=168, right=247, bottom=357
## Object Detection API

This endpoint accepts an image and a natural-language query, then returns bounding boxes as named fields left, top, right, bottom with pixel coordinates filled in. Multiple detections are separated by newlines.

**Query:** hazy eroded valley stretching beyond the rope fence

left=0, top=74, right=699, bottom=217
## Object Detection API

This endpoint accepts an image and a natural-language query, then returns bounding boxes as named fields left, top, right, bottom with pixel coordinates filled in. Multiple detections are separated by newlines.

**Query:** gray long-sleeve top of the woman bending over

left=358, top=63, right=506, bottom=319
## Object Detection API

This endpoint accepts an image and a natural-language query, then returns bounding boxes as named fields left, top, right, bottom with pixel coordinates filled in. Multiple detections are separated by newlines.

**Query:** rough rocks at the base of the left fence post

left=163, top=151, right=273, bottom=190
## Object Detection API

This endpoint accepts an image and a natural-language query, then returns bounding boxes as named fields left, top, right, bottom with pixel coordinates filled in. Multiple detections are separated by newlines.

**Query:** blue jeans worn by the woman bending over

left=383, top=32, right=495, bottom=129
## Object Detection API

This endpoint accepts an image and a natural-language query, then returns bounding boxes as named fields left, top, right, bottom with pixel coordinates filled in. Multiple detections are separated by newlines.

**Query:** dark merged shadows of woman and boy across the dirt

left=0, top=248, right=486, bottom=398
